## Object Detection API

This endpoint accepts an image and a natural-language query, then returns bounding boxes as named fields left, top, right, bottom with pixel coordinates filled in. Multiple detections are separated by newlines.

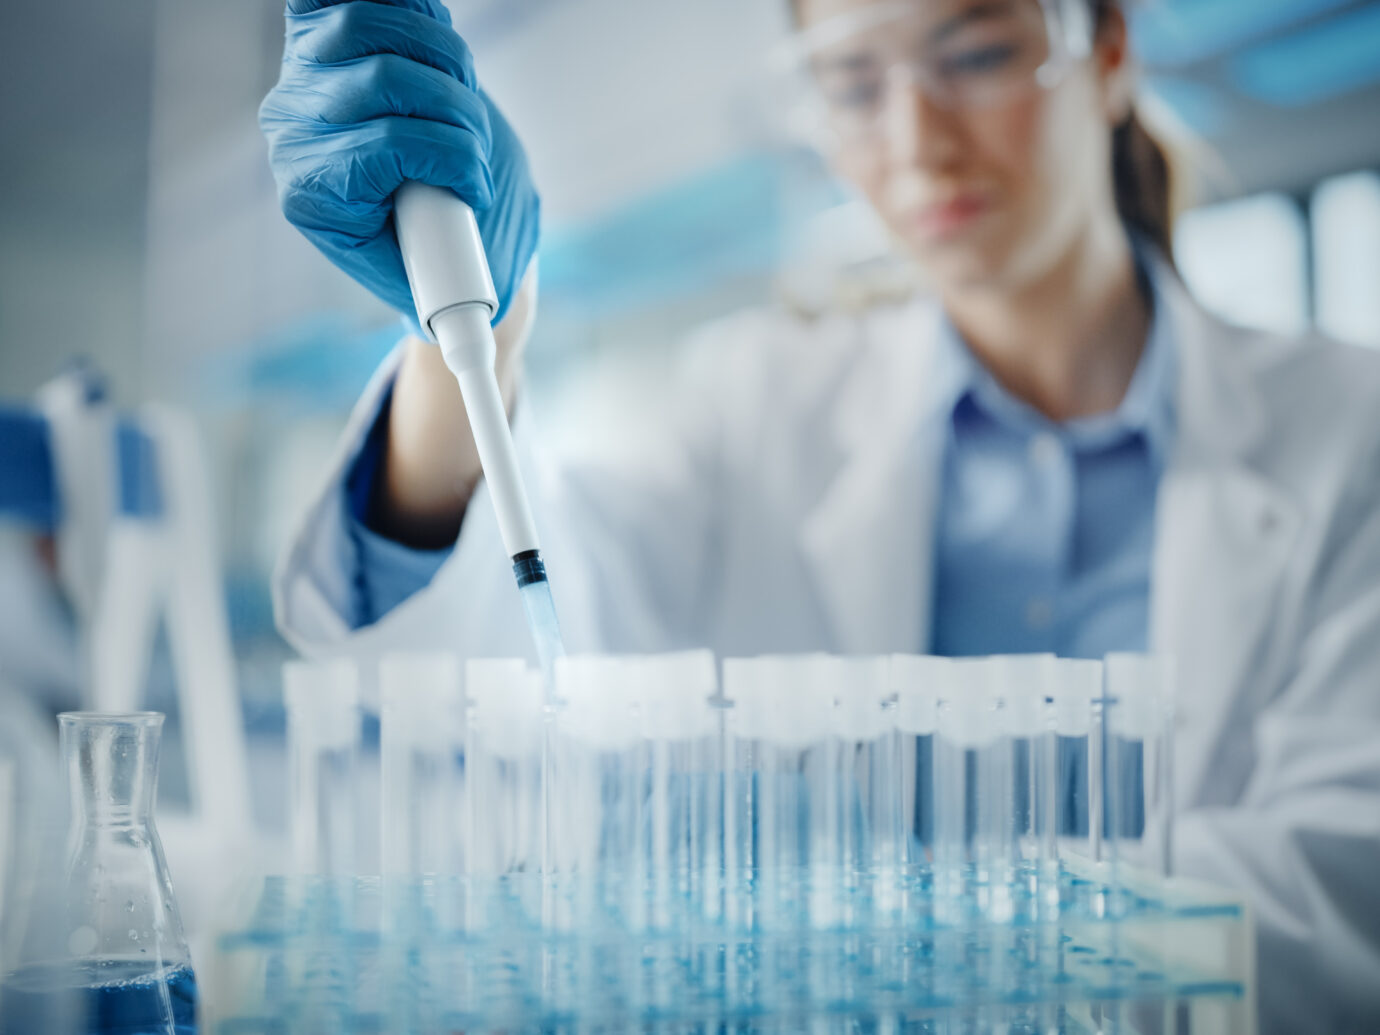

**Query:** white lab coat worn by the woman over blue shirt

left=276, top=260, right=1380, bottom=1032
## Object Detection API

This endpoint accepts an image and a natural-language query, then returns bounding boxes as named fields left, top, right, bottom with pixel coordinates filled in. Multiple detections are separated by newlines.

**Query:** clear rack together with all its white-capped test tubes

left=234, top=651, right=1254, bottom=1035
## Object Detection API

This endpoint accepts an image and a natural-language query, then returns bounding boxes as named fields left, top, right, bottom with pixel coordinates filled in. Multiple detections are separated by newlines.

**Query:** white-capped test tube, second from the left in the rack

left=380, top=653, right=464, bottom=876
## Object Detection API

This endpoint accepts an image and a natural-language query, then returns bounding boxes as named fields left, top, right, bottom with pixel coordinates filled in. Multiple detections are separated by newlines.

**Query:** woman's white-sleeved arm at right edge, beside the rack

left=1176, top=457, right=1380, bottom=1032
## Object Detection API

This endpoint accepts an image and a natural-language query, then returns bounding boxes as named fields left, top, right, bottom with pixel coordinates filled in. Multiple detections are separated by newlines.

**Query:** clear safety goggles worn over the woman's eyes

left=773, top=0, right=1093, bottom=144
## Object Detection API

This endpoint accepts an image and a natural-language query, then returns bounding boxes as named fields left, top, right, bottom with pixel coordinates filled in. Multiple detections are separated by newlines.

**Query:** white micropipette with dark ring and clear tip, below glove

left=393, top=182, right=564, bottom=687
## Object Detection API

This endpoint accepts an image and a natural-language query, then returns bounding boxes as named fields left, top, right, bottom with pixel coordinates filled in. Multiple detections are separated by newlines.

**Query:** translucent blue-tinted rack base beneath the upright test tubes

left=204, top=868, right=1253, bottom=1035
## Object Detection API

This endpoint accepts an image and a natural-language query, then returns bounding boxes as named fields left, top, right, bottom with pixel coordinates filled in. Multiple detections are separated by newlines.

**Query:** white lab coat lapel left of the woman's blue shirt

left=800, top=302, right=943, bottom=654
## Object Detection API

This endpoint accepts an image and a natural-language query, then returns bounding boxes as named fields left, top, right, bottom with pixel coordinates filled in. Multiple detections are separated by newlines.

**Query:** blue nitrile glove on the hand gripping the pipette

left=259, top=0, right=541, bottom=326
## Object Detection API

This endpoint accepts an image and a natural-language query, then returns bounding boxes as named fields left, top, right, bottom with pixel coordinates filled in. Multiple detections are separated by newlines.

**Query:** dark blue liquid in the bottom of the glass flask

left=0, top=959, right=197, bottom=1035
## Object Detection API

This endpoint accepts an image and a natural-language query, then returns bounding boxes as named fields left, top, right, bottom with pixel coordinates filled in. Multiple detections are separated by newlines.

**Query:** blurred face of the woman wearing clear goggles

left=798, top=0, right=1123, bottom=293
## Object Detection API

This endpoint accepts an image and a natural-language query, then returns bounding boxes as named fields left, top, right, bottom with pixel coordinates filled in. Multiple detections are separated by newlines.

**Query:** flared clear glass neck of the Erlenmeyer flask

left=59, top=712, right=163, bottom=827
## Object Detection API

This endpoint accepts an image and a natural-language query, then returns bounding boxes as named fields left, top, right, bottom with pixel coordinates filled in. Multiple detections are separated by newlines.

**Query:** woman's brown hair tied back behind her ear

left=789, top=0, right=1176, bottom=262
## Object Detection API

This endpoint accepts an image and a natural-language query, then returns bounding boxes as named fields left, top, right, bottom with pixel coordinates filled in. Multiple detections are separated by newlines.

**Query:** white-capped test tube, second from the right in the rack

left=1052, top=658, right=1103, bottom=865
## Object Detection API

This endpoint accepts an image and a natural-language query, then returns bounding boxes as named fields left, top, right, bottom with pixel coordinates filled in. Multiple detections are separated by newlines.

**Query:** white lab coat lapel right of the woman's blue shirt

left=1150, top=269, right=1301, bottom=806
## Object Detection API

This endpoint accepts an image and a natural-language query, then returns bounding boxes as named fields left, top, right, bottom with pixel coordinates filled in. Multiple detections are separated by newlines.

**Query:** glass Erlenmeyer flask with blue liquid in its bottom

left=0, top=712, right=196, bottom=1035
